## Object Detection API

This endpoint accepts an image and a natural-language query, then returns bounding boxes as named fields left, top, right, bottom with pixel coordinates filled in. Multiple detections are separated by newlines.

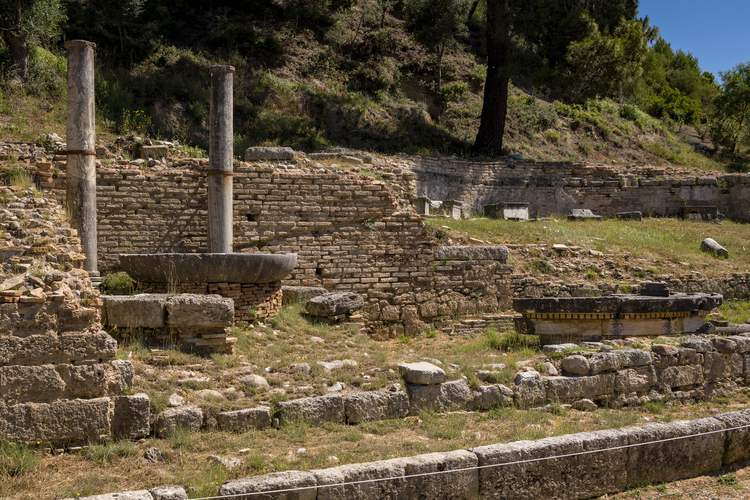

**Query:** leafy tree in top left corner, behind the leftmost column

left=0, top=0, right=66, bottom=82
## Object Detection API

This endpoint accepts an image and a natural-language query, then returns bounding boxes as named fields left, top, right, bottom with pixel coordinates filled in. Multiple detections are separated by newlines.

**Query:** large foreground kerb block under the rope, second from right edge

left=622, top=418, right=724, bottom=487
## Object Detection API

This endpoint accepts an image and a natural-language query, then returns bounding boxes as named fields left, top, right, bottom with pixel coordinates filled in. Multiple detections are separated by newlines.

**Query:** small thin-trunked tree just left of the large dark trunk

left=406, top=0, right=469, bottom=94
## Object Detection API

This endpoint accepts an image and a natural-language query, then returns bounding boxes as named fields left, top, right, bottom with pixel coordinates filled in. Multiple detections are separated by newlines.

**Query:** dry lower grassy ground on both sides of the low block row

left=0, top=296, right=750, bottom=498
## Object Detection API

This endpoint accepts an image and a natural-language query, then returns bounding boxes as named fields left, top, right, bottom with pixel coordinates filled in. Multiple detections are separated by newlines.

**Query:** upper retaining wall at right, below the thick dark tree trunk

left=411, top=157, right=750, bottom=220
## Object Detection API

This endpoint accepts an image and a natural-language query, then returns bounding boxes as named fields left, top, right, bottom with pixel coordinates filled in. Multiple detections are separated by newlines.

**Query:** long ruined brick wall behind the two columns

left=43, top=159, right=511, bottom=336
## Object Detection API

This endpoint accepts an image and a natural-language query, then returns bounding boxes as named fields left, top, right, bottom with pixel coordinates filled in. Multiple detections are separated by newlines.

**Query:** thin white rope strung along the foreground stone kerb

left=187, top=425, right=750, bottom=500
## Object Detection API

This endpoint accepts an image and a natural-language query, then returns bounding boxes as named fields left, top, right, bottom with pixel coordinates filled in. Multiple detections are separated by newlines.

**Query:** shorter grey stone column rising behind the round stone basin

left=208, top=66, right=234, bottom=253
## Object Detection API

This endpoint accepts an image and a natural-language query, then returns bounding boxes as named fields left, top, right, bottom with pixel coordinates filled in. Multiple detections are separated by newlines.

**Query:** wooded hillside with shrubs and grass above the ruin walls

left=0, top=0, right=746, bottom=171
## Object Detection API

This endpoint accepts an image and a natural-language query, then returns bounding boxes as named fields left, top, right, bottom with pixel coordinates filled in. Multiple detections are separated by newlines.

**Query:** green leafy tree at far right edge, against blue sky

left=711, top=62, right=750, bottom=153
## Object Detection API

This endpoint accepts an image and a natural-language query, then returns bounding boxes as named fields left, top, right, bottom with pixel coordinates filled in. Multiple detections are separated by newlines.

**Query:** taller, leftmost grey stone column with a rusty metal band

left=65, top=40, right=98, bottom=276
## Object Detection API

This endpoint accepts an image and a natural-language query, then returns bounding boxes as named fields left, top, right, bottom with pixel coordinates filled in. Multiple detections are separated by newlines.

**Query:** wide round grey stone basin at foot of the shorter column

left=120, top=253, right=297, bottom=283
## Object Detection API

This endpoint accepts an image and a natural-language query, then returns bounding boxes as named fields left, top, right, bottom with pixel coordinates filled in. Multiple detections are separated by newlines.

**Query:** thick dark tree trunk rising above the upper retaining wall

left=474, top=0, right=510, bottom=156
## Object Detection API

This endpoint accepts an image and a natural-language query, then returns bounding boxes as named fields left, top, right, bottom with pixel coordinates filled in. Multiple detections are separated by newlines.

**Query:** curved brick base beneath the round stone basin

left=138, top=282, right=282, bottom=322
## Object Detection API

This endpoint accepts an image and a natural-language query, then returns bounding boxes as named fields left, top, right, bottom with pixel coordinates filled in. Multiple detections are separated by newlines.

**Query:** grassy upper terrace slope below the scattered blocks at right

left=427, top=216, right=750, bottom=285
